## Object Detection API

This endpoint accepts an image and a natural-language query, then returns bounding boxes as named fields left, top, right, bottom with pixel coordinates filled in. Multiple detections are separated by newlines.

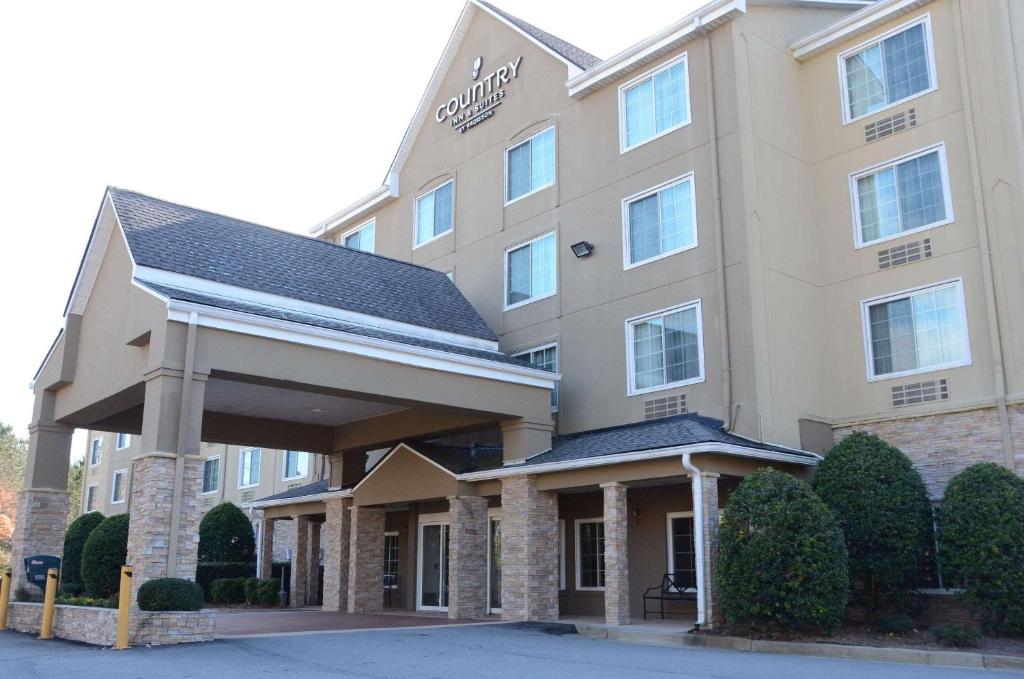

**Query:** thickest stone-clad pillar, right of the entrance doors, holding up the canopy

left=502, top=476, right=558, bottom=622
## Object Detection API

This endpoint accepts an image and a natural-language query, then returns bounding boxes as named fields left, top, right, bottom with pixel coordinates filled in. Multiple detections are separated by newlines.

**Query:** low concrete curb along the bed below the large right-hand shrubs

left=575, top=623, right=1024, bottom=670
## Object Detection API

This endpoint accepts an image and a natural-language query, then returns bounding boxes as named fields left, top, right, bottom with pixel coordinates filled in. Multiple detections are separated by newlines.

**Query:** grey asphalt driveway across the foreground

left=0, top=625, right=1024, bottom=679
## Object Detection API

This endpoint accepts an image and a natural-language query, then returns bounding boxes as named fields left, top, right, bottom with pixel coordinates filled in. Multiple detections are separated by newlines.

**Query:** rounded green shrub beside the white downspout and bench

left=716, top=469, right=849, bottom=634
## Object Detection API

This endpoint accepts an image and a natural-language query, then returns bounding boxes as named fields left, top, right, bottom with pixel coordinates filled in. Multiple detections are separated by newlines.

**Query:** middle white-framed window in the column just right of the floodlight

left=623, top=172, right=697, bottom=268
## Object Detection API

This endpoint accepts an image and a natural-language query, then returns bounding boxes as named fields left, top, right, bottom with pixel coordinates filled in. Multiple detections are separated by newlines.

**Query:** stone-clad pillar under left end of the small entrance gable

left=348, top=507, right=384, bottom=613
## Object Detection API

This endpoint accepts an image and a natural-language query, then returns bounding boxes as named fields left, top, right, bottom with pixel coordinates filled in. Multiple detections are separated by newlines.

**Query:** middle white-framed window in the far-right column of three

left=851, top=144, right=952, bottom=247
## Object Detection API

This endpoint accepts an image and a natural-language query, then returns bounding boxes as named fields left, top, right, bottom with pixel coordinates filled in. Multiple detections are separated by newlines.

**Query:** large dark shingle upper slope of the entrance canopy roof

left=109, top=187, right=498, bottom=340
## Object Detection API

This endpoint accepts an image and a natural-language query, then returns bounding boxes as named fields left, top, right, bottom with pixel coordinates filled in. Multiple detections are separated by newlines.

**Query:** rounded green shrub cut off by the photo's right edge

left=939, top=462, right=1024, bottom=635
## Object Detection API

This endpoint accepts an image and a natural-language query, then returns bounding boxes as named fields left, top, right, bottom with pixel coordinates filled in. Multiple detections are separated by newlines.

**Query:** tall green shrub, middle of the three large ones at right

left=814, top=431, right=932, bottom=620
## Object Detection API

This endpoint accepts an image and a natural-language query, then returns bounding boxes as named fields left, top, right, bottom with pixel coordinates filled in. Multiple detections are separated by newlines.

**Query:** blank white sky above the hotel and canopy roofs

left=0, top=0, right=702, bottom=453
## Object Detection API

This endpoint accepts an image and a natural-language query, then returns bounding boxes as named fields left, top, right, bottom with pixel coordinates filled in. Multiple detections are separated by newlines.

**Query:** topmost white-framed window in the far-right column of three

left=839, top=14, right=938, bottom=124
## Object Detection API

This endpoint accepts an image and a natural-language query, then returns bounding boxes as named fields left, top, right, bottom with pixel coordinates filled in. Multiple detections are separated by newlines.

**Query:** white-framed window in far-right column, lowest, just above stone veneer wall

left=861, top=279, right=971, bottom=381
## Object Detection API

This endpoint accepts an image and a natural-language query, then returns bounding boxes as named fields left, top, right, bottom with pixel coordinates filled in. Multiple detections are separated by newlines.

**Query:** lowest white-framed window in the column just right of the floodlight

left=626, top=299, right=705, bottom=396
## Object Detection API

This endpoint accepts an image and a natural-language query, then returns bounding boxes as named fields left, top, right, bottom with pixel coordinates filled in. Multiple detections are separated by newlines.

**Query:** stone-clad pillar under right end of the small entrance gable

left=449, top=496, right=487, bottom=619
